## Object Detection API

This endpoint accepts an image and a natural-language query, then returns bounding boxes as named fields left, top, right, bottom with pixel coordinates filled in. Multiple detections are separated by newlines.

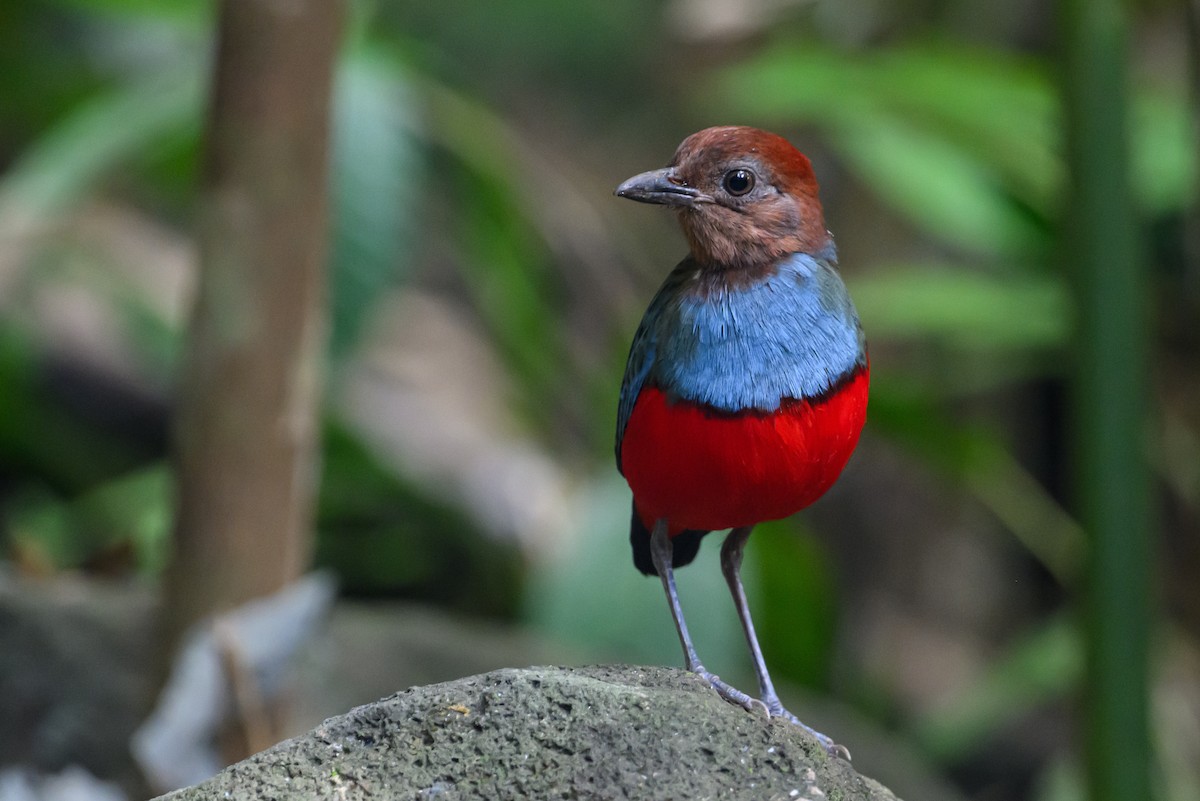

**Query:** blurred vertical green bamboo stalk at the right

left=1060, top=0, right=1152, bottom=801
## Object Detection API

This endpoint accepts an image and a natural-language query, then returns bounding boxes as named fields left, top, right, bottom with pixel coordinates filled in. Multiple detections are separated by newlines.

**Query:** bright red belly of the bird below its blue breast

left=620, top=368, right=870, bottom=536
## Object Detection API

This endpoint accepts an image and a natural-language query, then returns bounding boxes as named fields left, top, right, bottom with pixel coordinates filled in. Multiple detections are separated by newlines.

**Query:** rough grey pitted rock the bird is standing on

left=162, top=666, right=895, bottom=801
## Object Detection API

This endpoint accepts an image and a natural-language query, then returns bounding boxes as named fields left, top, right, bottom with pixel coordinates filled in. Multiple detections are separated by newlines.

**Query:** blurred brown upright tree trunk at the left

left=164, top=0, right=342, bottom=650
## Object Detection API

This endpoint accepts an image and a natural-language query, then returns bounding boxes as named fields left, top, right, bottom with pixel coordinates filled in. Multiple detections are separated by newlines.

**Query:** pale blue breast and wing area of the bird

left=617, top=249, right=866, bottom=463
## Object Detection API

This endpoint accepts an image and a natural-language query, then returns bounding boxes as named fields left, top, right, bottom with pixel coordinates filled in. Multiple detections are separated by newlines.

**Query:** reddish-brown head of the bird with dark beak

left=617, top=126, right=830, bottom=270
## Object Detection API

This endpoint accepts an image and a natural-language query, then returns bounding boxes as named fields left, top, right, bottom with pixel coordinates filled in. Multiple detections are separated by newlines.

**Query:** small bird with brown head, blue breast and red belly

left=616, top=126, right=870, bottom=760
